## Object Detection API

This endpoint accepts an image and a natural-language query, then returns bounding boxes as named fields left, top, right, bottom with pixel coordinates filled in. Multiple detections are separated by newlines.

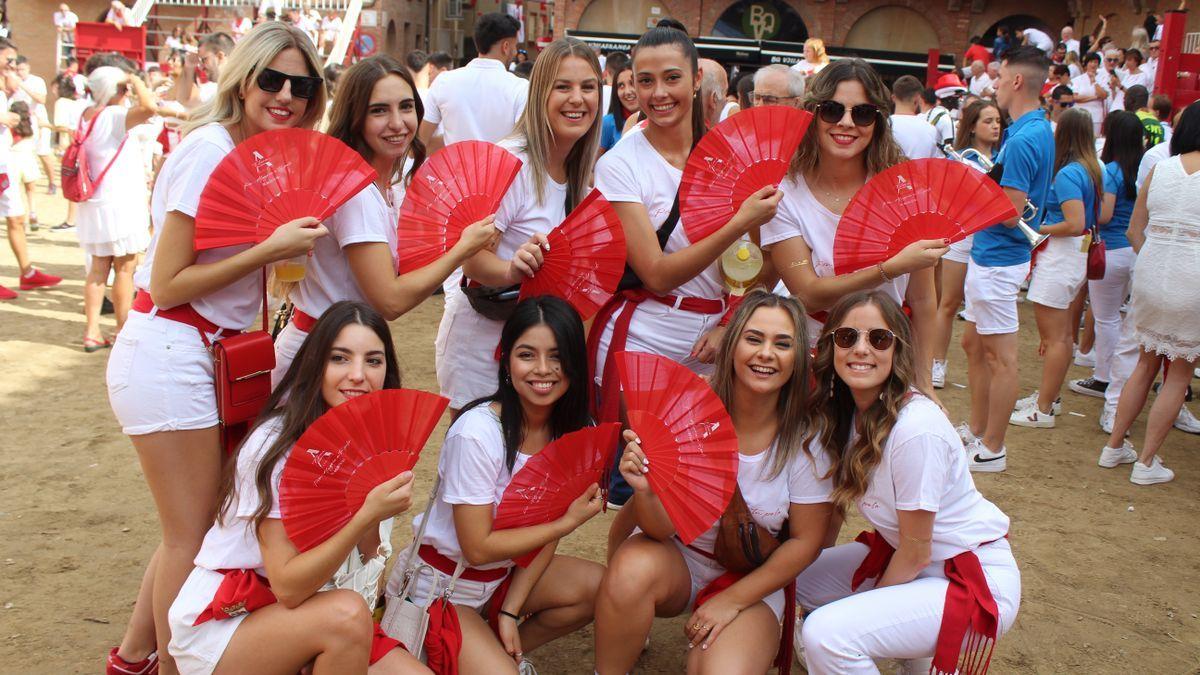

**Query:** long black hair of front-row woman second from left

left=456, top=295, right=592, bottom=472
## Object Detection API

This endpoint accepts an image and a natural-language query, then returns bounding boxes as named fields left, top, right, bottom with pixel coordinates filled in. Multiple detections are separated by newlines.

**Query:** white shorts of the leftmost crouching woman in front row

left=167, top=567, right=248, bottom=675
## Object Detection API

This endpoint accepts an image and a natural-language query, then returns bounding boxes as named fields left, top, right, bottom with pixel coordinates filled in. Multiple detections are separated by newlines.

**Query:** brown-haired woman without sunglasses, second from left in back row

left=271, top=55, right=496, bottom=384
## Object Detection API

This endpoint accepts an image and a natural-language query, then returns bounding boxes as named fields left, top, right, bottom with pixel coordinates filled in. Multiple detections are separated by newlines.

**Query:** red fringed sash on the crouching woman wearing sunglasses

left=850, top=531, right=1008, bottom=675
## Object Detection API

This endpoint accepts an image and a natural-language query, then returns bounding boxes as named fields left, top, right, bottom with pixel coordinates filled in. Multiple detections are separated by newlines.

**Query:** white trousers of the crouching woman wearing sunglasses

left=796, top=539, right=1021, bottom=675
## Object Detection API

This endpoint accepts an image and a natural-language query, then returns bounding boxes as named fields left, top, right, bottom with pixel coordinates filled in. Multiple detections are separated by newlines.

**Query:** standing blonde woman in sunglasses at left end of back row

left=107, top=22, right=326, bottom=673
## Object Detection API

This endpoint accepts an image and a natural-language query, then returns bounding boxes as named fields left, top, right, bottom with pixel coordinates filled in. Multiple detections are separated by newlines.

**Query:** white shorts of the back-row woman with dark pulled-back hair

left=593, top=295, right=721, bottom=384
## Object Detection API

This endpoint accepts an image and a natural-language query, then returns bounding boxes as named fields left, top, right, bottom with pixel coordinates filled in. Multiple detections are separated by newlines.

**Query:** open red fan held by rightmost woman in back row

left=833, top=159, right=1016, bottom=274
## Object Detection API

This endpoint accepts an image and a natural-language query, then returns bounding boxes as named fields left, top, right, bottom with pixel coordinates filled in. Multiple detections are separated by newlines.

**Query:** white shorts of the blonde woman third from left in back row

left=434, top=289, right=504, bottom=410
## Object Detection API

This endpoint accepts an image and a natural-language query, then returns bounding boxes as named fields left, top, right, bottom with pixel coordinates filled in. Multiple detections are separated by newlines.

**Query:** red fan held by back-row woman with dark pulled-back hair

left=679, top=106, right=812, bottom=243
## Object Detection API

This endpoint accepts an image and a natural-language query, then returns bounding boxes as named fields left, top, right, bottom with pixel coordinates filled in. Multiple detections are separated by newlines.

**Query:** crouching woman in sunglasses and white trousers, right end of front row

left=796, top=291, right=1021, bottom=675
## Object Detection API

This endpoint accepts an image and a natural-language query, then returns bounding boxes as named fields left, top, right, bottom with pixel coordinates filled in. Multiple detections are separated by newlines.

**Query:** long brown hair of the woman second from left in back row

left=326, top=54, right=425, bottom=183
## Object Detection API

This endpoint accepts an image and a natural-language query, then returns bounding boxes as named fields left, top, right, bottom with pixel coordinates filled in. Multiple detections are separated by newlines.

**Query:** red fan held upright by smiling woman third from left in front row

left=617, top=352, right=738, bottom=544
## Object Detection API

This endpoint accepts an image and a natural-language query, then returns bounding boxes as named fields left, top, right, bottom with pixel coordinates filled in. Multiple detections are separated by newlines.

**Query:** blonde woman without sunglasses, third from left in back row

left=437, top=37, right=604, bottom=410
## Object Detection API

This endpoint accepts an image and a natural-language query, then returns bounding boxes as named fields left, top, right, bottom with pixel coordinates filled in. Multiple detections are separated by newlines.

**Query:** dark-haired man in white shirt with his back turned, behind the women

left=418, top=12, right=529, bottom=151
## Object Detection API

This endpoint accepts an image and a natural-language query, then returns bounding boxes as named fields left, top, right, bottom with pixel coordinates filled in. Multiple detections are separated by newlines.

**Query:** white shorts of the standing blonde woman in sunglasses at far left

left=106, top=312, right=218, bottom=436
